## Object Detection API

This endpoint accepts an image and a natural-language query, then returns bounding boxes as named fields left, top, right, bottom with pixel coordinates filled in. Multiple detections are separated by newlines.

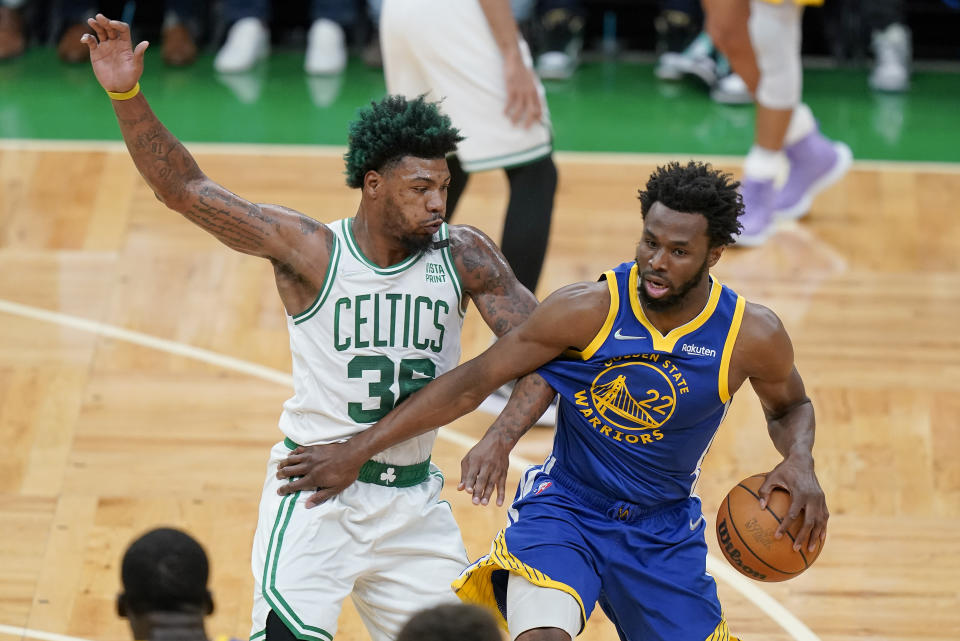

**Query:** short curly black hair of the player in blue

left=639, top=160, right=743, bottom=247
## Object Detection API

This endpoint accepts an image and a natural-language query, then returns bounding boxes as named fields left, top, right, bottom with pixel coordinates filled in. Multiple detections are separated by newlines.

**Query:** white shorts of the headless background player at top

left=380, top=0, right=553, bottom=172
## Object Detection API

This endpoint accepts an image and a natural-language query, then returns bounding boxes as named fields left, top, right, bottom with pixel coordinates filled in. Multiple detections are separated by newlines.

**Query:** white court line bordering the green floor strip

left=0, top=138, right=960, bottom=174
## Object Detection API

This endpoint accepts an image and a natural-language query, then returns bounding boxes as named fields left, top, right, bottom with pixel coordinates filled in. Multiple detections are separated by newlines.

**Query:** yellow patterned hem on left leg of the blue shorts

left=451, top=530, right=587, bottom=631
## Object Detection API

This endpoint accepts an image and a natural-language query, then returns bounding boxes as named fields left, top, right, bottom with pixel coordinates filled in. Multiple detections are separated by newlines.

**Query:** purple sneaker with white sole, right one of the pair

left=773, top=129, right=853, bottom=218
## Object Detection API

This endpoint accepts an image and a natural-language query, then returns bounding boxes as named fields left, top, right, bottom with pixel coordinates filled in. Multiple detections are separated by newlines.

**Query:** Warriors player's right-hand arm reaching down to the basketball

left=735, top=304, right=830, bottom=551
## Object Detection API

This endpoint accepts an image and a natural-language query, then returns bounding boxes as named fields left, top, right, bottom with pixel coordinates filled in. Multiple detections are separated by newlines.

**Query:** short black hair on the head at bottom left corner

left=120, top=528, right=211, bottom=614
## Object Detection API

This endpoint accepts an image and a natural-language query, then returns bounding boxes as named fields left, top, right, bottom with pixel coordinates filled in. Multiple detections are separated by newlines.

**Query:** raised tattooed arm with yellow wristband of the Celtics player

left=83, top=14, right=332, bottom=313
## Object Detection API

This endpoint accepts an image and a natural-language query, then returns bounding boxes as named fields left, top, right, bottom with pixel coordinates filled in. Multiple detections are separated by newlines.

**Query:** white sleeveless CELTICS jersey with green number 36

left=280, top=218, right=465, bottom=465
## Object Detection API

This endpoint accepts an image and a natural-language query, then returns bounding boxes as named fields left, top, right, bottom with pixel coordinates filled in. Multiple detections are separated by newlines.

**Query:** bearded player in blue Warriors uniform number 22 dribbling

left=280, top=162, right=828, bottom=641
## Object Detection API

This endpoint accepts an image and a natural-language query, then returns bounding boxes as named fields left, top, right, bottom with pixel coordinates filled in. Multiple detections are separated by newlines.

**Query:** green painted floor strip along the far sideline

left=0, top=48, right=960, bottom=162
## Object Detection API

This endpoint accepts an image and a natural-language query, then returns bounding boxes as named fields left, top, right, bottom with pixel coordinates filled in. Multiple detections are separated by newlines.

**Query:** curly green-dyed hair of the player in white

left=343, top=96, right=463, bottom=188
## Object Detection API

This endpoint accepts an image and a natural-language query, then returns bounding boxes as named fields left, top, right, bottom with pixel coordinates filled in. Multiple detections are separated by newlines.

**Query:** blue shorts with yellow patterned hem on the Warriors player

left=453, top=466, right=729, bottom=641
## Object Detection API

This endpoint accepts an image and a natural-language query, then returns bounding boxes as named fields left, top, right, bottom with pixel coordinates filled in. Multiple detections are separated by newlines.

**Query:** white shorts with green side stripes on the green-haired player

left=250, top=442, right=467, bottom=641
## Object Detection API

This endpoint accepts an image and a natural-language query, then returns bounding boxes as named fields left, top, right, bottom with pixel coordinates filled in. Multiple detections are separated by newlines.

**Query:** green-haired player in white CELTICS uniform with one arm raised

left=83, top=14, right=556, bottom=641
